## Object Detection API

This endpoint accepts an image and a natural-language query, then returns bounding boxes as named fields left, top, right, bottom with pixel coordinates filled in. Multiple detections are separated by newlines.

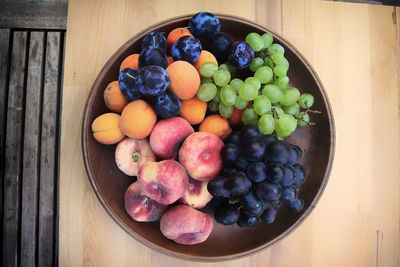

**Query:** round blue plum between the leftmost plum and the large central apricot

left=138, top=65, right=170, bottom=96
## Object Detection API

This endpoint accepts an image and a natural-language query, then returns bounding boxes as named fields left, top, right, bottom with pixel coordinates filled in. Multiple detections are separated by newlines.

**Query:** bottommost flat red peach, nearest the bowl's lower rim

left=160, top=205, right=213, bottom=245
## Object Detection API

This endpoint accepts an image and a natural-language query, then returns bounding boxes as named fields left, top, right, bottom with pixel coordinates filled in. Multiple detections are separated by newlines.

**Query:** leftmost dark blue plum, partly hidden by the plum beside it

left=118, top=68, right=142, bottom=101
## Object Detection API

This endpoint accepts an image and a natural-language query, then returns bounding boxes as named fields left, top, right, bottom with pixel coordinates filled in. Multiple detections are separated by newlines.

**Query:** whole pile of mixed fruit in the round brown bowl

left=92, top=12, right=314, bottom=245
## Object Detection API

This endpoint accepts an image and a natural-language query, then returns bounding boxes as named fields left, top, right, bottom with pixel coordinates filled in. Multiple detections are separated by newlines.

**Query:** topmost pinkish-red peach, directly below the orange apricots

left=150, top=117, right=194, bottom=159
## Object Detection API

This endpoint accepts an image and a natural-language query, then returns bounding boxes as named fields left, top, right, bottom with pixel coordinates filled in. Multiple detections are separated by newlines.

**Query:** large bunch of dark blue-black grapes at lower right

left=207, top=125, right=306, bottom=227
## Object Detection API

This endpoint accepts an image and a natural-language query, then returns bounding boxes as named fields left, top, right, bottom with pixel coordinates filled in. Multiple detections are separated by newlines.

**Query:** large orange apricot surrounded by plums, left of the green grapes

left=166, top=60, right=200, bottom=99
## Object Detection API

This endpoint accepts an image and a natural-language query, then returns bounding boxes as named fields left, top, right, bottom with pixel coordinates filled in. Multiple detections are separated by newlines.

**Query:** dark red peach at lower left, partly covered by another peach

left=125, top=181, right=168, bottom=222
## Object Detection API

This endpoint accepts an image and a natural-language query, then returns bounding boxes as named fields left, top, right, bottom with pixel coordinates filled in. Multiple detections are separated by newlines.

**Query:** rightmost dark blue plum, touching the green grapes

left=228, top=42, right=254, bottom=69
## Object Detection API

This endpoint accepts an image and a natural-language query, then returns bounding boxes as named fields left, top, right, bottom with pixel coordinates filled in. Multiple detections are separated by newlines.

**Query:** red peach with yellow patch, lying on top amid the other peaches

left=138, top=160, right=188, bottom=205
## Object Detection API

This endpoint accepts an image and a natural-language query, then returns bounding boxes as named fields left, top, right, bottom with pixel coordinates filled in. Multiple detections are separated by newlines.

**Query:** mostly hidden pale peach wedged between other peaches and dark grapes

left=179, top=176, right=213, bottom=209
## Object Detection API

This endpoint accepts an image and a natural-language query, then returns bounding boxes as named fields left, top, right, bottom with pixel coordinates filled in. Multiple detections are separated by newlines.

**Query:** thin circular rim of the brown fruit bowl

left=81, top=13, right=336, bottom=262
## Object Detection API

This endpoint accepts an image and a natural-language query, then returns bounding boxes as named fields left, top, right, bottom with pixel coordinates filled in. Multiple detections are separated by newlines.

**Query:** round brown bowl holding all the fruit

left=82, top=14, right=335, bottom=261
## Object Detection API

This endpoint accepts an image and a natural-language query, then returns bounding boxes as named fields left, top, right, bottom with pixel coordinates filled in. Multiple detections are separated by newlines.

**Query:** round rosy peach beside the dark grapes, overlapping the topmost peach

left=179, top=132, right=224, bottom=181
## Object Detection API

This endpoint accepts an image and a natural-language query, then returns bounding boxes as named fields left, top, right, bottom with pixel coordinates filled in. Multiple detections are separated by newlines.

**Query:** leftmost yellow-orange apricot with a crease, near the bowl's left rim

left=92, top=113, right=125, bottom=145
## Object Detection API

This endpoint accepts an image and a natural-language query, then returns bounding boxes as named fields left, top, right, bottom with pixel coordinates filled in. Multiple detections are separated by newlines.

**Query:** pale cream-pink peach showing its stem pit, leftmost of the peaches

left=115, top=138, right=156, bottom=176
